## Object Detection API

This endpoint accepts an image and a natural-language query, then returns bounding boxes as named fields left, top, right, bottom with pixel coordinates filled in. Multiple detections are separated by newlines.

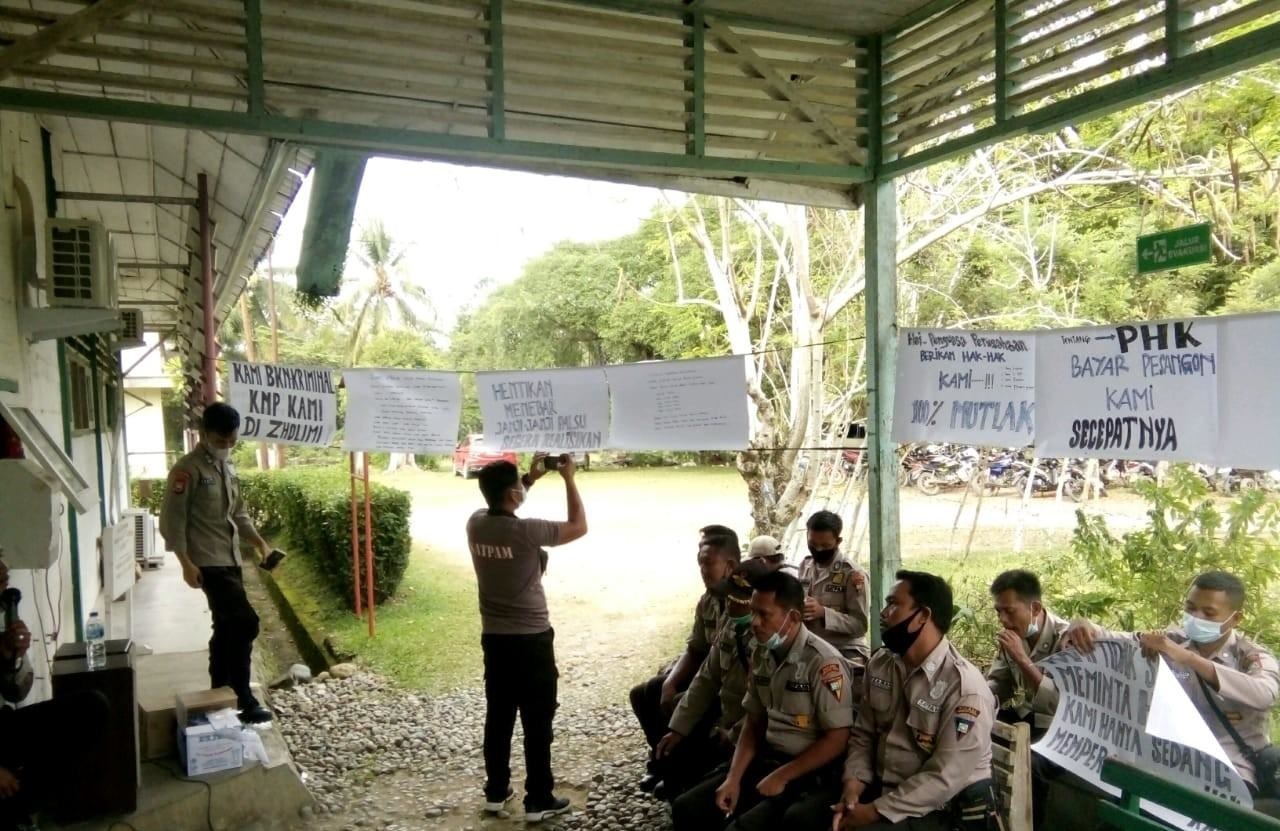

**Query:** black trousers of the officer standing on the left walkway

left=200, top=566, right=257, bottom=709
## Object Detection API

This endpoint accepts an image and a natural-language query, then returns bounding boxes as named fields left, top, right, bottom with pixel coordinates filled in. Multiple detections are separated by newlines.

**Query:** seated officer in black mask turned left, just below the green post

left=819, top=571, right=996, bottom=831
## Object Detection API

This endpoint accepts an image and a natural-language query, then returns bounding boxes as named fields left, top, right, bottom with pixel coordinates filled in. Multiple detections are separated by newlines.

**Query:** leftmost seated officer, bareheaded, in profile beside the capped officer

left=630, top=525, right=742, bottom=793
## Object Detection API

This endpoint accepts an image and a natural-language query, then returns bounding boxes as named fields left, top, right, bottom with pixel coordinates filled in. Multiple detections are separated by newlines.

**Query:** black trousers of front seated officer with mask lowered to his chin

left=671, top=752, right=840, bottom=831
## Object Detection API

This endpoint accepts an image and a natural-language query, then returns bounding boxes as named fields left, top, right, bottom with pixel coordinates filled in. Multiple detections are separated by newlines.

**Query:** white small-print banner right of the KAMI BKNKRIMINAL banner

left=342, top=369, right=462, bottom=453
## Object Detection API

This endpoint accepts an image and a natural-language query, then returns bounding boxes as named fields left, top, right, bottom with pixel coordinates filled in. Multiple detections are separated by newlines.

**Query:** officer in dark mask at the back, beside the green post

left=797, top=511, right=870, bottom=665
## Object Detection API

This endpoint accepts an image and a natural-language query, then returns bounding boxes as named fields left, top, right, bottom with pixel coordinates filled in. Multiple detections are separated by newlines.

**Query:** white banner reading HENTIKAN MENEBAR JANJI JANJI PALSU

left=476, top=367, right=609, bottom=453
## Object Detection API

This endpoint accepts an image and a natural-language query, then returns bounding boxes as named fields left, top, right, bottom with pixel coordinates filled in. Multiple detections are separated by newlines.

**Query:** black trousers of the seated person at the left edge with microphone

left=0, top=690, right=110, bottom=831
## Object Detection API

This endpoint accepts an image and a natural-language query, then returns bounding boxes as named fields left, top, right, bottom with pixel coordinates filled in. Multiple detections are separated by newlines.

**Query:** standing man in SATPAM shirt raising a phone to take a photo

left=467, top=455, right=586, bottom=822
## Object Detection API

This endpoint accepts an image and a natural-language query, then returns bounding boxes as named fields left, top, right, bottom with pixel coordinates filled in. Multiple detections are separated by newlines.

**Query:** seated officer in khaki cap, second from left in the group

left=653, top=558, right=774, bottom=799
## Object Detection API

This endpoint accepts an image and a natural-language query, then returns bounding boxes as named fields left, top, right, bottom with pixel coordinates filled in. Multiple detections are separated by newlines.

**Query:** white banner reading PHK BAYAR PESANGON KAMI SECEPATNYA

left=1036, top=318, right=1222, bottom=461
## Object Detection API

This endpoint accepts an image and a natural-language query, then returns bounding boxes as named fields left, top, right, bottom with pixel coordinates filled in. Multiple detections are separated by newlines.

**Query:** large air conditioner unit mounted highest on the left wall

left=45, top=219, right=116, bottom=309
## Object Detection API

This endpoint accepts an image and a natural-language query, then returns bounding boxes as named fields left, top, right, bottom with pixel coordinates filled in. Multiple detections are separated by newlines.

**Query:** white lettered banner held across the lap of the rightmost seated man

left=1032, top=639, right=1253, bottom=831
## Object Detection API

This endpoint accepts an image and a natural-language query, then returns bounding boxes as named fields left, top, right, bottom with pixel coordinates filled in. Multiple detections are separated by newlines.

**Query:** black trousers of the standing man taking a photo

left=480, top=629, right=559, bottom=802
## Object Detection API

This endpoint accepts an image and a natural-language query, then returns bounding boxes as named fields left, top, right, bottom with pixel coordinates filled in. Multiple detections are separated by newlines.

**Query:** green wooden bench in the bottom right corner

left=1098, top=759, right=1280, bottom=831
